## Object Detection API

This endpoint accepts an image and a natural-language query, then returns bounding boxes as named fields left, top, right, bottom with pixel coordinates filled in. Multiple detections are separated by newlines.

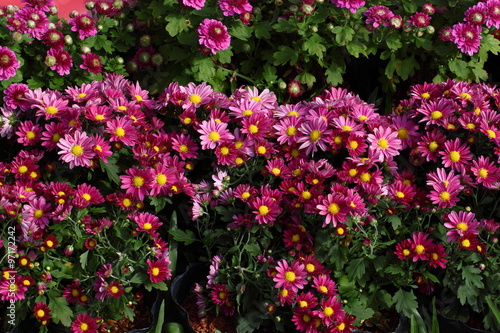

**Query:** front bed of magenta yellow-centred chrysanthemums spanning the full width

left=0, top=74, right=500, bottom=332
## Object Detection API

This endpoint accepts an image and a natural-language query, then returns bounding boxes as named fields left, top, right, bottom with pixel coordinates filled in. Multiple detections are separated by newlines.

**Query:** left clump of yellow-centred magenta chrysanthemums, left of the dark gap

left=0, top=75, right=176, bottom=332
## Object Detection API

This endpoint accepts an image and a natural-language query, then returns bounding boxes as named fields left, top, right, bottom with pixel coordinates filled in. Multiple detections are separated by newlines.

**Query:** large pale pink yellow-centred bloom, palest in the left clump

left=57, top=131, right=95, bottom=169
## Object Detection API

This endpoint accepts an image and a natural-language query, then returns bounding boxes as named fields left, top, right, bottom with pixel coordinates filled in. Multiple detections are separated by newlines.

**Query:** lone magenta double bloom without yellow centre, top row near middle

left=198, top=19, right=231, bottom=54
